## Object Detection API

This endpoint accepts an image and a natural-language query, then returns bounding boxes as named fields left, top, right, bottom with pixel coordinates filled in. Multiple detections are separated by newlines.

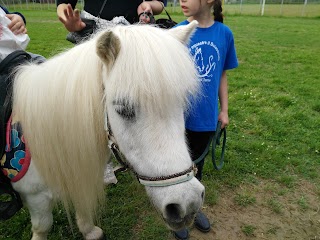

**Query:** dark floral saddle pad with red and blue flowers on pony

left=0, top=117, right=31, bottom=182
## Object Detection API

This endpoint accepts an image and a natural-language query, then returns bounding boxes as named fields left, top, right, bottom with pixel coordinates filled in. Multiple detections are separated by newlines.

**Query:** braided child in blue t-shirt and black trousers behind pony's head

left=174, top=0, right=238, bottom=239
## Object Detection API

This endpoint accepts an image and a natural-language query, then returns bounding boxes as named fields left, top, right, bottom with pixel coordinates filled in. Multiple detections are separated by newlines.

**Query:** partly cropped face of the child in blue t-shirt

left=180, top=0, right=210, bottom=17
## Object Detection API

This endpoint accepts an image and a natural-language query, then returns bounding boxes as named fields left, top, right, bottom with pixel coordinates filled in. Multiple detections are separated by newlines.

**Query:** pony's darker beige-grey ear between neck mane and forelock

left=96, top=31, right=120, bottom=65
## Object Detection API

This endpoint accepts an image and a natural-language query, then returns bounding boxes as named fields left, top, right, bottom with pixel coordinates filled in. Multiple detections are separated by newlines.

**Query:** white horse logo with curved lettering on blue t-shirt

left=189, top=41, right=220, bottom=82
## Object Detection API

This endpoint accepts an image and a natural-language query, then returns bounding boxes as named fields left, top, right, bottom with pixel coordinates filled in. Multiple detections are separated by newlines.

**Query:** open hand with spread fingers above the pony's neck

left=59, top=4, right=86, bottom=32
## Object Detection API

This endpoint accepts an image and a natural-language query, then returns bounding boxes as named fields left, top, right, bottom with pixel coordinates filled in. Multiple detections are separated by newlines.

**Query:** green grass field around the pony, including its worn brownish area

left=0, top=10, right=320, bottom=240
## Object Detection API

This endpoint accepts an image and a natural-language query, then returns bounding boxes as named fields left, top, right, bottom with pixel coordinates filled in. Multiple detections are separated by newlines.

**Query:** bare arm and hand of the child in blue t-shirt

left=218, top=71, right=229, bottom=128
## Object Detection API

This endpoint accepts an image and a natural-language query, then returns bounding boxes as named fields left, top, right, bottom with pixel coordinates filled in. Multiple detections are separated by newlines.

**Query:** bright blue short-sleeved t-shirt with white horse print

left=177, top=20, right=238, bottom=132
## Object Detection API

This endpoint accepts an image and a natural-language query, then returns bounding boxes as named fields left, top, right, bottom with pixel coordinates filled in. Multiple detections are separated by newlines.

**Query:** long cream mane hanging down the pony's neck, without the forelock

left=13, top=36, right=108, bottom=221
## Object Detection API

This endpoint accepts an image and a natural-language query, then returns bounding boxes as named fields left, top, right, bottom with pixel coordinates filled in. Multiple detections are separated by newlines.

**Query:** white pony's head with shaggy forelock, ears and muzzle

left=97, top=22, right=204, bottom=230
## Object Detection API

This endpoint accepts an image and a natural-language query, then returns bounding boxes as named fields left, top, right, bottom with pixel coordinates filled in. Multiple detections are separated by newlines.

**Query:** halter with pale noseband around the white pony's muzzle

left=105, top=113, right=197, bottom=187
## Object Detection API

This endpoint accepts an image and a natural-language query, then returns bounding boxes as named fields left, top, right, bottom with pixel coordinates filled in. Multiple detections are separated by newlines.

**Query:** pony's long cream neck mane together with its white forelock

left=13, top=25, right=198, bottom=221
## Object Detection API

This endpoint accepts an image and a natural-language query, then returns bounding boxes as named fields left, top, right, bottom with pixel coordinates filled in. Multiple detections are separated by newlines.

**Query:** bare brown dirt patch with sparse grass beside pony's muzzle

left=171, top=181, right=320, bottom=240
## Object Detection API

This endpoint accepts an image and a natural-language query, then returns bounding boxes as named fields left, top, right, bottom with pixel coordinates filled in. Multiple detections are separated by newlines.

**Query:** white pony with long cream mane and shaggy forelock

left=12, top=22, right=204, bottom=240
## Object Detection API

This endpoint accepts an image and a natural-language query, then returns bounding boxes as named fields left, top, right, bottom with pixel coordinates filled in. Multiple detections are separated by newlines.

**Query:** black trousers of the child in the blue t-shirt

left=186, top=129, right=214, bottom=181
